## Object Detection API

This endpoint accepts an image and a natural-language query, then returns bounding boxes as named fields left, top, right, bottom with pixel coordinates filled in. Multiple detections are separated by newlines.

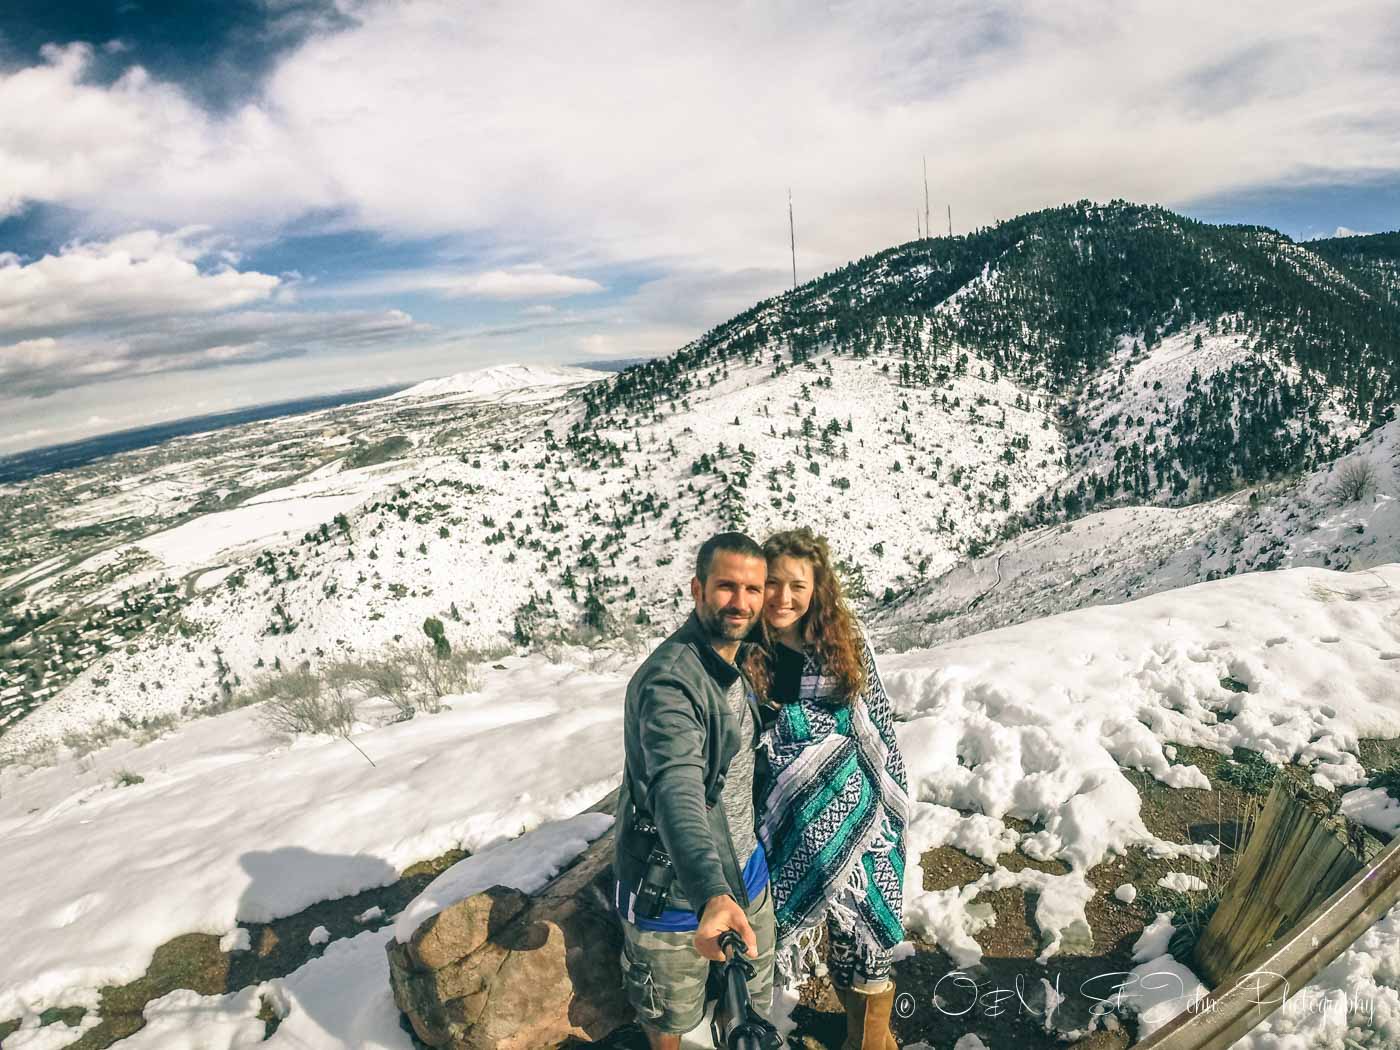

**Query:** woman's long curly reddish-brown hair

left=743, top=526, right=865, bottom=703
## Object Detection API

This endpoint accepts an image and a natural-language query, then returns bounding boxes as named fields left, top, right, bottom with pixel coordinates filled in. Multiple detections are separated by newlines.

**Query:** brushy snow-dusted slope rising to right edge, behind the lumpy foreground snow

left=872, top=420, right=1400, bottom=648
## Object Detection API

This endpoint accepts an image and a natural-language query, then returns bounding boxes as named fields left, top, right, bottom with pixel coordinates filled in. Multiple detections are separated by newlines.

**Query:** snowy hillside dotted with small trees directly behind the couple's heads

left=0, top=354, right=1063, bottom=753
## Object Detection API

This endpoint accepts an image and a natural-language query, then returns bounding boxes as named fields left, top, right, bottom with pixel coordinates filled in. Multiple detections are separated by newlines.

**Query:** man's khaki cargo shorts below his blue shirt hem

left=622, top=886, right=774, bottom=1035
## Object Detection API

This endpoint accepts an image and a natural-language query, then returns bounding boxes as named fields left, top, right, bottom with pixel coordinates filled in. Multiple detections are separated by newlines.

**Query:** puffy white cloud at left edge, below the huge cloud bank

left=0, top=230, right=279, bottom=335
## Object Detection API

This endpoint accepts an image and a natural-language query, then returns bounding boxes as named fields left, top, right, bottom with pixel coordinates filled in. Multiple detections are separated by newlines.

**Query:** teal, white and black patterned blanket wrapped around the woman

left=759, top=630, right=909, bottom=979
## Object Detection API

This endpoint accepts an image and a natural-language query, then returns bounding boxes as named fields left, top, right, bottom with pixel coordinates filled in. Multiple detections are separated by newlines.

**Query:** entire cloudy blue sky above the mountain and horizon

left=0, top=0, right=1400, bottom=455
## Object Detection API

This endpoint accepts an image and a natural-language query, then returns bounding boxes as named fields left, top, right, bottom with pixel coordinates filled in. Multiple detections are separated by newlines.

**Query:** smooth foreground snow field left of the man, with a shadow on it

left=0, top=657, right=622, bottom=1018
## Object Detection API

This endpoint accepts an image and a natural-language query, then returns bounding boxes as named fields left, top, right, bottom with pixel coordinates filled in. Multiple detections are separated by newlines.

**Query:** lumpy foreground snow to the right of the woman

left=881, top=566, right=1400, bottom=966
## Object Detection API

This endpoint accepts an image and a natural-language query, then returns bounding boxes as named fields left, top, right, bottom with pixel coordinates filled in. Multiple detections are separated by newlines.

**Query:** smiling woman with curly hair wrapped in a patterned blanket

left=746, top=528, right=909, bottom=1050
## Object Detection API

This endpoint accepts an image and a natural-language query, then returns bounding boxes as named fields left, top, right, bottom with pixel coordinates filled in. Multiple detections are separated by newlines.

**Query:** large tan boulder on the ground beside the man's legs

left=388, top=792, right=633, bottom=1050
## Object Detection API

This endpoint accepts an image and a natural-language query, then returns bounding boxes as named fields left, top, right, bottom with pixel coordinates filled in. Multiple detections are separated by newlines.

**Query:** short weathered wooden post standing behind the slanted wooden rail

left=1194, top=776, right=1379, bottom=987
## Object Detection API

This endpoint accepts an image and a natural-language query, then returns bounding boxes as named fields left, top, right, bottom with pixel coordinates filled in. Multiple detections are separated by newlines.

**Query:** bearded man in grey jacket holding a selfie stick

left=613, top=532, right=774, bottom=1050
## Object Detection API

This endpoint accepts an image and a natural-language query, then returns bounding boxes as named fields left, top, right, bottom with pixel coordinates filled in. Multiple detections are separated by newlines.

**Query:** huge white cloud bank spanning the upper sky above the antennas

left=10, top=0, right=1400, bottom=275
